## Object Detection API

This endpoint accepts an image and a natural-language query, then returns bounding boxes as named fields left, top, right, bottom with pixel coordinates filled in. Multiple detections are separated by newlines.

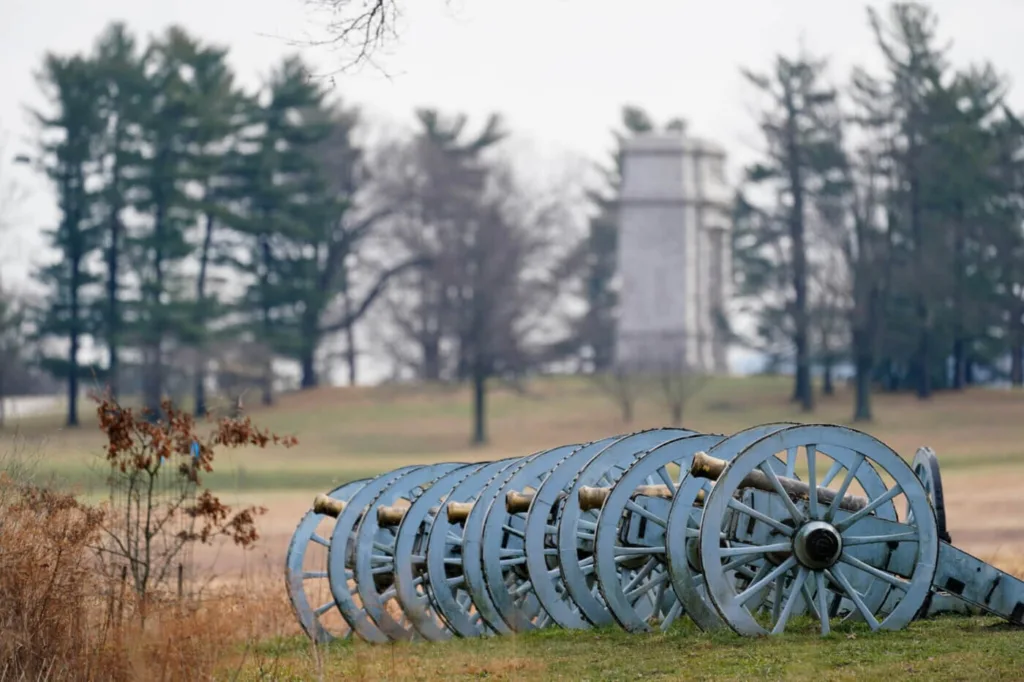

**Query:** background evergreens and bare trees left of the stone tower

left=0, top=24, right=602, bottom=441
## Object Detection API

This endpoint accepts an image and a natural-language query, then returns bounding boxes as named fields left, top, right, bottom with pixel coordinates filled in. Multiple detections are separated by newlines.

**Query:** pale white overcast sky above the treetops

left=0, top=0, right=1024, bottom=374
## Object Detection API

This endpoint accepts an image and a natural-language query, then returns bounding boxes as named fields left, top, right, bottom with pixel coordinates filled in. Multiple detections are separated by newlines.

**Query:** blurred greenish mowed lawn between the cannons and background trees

left=8, top=377, right=1024, bottom=495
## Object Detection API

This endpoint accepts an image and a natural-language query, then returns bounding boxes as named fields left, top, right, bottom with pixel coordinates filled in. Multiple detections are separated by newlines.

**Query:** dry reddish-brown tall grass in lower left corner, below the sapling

left=0, top=476, right=298, bottom=682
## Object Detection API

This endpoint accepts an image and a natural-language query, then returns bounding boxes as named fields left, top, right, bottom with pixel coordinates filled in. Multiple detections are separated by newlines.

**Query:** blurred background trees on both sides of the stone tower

left=0, top=3, right=1024, bottom=442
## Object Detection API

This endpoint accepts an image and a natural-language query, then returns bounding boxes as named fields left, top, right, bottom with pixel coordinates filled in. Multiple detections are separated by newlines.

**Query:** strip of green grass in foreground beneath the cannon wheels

left=238, top=616, right=1024, bottom=682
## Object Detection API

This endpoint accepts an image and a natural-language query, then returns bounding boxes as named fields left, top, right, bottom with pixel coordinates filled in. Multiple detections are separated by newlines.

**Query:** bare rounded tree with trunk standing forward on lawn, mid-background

left=370, top=111, right=571, bottom=443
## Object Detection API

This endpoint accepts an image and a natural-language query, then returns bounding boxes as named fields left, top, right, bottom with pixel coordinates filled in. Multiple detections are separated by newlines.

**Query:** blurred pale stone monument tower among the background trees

left=615, top=127, right=732, bottom=374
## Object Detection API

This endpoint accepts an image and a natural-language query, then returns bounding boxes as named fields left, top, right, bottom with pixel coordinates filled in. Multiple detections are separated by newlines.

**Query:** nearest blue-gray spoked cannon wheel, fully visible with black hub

left=699, top=425, right=938, bottom=635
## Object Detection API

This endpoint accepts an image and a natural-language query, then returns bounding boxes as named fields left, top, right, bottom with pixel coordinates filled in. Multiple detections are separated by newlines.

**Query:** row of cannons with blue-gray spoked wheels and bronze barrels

left=286, top=423, right=1024, bottom=643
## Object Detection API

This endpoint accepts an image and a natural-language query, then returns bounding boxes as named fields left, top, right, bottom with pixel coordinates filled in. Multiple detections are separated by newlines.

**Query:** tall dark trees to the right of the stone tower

left=734, top=2, right=1024, bottom=420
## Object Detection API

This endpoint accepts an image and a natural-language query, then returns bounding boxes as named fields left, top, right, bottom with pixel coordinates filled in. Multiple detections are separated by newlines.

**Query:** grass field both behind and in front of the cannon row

left=0, top=377, right=1024, bottom=680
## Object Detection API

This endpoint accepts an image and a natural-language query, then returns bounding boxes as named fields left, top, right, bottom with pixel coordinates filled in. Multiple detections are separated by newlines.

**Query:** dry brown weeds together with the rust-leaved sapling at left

left=0, top=395, right=296, bottom=682
